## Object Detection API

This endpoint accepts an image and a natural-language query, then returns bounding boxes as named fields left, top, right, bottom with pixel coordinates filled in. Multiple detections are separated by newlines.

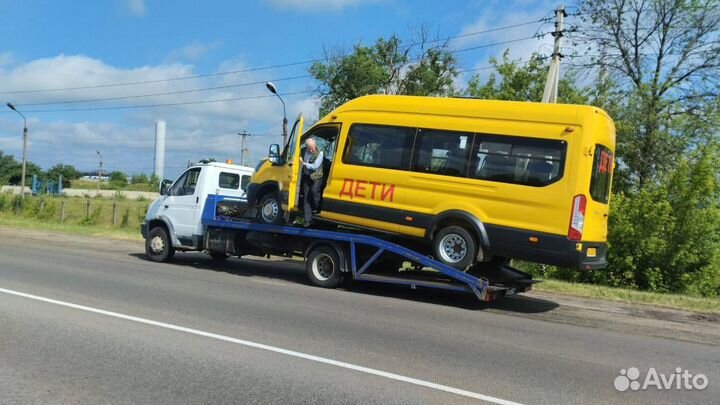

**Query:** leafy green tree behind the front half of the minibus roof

left=310, top=29, right=458, bottom=115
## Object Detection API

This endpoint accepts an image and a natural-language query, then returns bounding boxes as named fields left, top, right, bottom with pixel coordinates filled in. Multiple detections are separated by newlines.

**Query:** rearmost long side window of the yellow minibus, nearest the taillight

left=470, top=135, right=566, bottom=187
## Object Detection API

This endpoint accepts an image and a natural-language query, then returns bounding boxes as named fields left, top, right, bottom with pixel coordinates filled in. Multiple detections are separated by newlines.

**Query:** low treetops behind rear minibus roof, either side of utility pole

left=465, top=49, right=589, bottom=104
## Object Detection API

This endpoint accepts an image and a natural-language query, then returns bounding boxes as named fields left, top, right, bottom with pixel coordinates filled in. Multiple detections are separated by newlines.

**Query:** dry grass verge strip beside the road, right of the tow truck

left=533, top=280, right=720, bottom=314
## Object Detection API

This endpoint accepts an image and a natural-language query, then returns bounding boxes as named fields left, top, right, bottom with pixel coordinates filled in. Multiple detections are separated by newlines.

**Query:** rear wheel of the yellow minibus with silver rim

left=433, top=225, right=477, bottom=270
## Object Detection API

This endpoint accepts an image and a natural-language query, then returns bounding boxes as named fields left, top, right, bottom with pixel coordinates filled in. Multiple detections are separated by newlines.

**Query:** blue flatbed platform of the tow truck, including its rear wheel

left=201, top=195, right=537, bottom=302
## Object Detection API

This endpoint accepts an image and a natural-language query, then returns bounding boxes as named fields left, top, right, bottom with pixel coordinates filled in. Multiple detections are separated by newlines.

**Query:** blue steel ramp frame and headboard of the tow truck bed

left=201, top=194, right=498, bottom=301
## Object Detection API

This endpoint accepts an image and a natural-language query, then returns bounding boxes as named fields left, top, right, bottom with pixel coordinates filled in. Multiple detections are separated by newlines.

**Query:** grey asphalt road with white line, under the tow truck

left=0, top=229, right=720, bottom=404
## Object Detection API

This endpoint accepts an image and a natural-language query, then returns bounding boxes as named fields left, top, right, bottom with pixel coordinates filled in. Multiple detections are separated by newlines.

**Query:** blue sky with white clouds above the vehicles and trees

left=0, top=0, right=572, bottom=177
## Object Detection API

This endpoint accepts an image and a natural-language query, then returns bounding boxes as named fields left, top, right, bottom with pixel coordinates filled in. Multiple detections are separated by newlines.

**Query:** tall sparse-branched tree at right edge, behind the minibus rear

left=576, top=0, right=720, bottom=187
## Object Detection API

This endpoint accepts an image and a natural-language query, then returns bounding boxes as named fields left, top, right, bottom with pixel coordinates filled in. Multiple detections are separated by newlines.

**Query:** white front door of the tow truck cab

left=165, top=167, right=202, bottom=245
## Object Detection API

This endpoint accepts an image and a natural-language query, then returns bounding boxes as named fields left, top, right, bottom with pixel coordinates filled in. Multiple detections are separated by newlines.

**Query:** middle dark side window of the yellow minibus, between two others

left=412, top=129, right=473, bottom=177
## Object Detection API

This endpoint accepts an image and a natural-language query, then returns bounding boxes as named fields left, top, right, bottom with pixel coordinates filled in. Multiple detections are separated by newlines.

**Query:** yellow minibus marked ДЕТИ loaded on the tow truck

left=248, top=95, right=615, bottom=270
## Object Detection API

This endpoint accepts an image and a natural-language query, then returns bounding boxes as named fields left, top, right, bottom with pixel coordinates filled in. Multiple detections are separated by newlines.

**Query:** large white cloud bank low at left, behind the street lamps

left=0, top=55, right=318, bottom=176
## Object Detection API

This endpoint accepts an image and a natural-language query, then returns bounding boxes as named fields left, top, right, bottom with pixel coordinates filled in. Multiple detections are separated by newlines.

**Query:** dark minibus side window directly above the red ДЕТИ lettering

left=343, top=124, right=416, bottom=170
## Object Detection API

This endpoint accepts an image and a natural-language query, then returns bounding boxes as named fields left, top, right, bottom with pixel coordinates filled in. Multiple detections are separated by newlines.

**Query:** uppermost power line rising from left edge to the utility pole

left=0, top=17, right=547, bottom=94
